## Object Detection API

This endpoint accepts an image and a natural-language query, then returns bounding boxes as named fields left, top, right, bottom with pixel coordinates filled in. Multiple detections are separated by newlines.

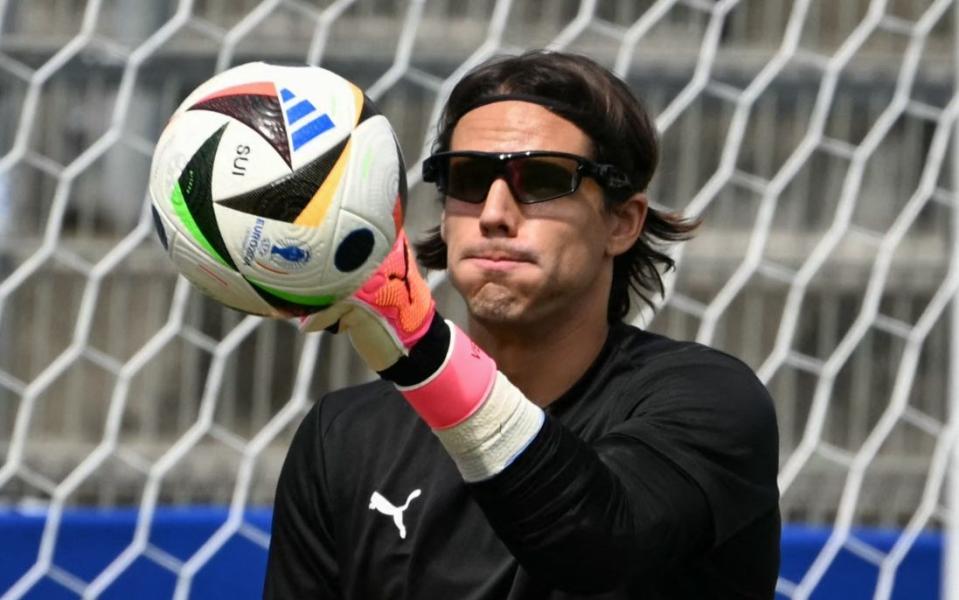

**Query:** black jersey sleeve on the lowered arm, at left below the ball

left=263, top=400, right=342, bottom=600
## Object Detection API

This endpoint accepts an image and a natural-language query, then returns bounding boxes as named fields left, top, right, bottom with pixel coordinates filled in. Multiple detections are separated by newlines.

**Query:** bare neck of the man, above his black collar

left=469, top=314, right=609, bottom=408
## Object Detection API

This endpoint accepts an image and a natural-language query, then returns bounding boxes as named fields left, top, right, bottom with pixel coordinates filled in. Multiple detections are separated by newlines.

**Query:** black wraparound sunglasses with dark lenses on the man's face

left=423, top=150, right=632, bottom=204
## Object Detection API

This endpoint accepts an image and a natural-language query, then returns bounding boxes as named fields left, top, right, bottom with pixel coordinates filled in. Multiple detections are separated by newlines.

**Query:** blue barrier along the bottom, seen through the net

left=0, top=507, right=942, bottom=600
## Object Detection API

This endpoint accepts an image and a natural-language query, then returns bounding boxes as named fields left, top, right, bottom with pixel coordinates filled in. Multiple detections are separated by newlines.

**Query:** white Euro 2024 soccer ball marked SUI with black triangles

left=150, top=63, right=406, bottom=318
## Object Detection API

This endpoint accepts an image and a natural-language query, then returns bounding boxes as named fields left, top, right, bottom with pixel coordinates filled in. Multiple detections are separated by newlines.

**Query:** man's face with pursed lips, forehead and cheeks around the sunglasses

left=443, top=101, right=615, bottom=325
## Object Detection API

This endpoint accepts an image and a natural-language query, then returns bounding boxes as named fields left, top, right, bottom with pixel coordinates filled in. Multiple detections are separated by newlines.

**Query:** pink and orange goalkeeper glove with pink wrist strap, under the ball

left=300, top=228, right=497, bottom=429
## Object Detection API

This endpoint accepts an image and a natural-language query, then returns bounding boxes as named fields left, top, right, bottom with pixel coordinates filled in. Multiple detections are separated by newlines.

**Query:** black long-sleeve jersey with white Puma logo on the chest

left=264, top=324, right=780, bottom=600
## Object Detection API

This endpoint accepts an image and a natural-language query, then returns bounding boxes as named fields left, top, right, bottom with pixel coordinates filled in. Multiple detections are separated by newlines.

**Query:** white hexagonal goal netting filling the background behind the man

left=0, top=0, right=959, bottom=599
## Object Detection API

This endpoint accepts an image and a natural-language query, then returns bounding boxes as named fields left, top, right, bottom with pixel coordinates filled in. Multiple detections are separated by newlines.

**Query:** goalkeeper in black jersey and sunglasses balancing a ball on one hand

left=265, top=52, right=779, bottom=600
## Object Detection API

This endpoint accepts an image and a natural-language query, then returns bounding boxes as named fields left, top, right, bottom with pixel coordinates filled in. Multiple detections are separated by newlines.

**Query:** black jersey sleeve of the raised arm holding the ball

left=469, top=350, right=778, bottom=593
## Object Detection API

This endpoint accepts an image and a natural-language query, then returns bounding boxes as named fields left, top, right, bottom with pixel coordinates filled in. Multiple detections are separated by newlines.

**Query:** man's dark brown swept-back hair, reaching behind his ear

left=416, top=50, right=699, bottom=322
